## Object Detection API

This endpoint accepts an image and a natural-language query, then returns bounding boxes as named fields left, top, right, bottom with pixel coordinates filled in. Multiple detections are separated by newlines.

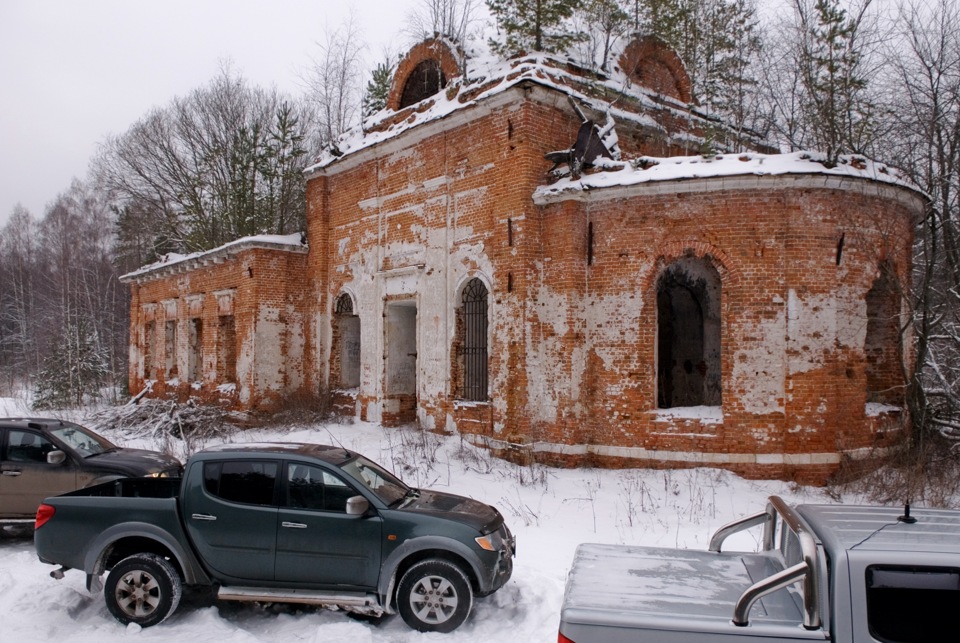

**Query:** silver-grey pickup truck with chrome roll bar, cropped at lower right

left=558, top=496, right=960, bottom=643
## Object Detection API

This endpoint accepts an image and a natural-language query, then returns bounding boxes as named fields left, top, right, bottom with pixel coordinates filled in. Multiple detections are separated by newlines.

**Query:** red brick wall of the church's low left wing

left=130, top=248, right=307, bottom=409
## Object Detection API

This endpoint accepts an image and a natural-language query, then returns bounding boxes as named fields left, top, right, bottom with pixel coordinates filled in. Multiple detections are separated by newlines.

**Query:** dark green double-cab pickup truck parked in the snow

left=35, top=443, right=515, bottom=632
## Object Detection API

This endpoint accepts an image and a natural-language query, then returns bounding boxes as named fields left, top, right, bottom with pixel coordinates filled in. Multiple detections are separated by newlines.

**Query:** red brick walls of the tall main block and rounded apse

left=308, top=87, right=911, bottom=480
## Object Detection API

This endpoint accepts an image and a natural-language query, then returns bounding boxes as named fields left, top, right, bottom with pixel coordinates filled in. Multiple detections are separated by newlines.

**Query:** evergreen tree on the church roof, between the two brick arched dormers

left=487, top=0, right=582, bottom=56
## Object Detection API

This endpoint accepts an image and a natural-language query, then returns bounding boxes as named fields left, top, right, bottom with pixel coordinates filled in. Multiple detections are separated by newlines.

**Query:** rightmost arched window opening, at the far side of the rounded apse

left=863, top=265, right=904, bottom=406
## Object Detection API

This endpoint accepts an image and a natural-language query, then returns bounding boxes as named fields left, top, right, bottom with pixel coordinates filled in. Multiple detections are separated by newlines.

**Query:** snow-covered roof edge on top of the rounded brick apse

left=534, top=152, right=919, bottom=203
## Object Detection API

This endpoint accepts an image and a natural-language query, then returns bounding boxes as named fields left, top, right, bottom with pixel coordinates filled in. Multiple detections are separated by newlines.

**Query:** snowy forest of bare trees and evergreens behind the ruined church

left=0, top=0, right=960, bottom=458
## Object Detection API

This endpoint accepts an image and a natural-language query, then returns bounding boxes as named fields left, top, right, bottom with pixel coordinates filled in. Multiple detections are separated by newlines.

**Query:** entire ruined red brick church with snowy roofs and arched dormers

left=124, top=38, right=923, bottom=482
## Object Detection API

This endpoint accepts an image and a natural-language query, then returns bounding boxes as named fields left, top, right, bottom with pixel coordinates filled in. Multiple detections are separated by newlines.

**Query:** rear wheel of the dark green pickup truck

left=103, top=554, right=182, bottom=627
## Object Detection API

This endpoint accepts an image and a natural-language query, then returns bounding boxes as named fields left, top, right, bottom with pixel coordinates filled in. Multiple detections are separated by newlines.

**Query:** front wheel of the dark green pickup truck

left=397, top=558, right=473, bottom=632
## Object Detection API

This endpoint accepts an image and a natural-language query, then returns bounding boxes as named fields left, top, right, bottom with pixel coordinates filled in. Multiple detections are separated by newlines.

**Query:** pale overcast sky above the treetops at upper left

left=0, top=0, right=420, bottom=226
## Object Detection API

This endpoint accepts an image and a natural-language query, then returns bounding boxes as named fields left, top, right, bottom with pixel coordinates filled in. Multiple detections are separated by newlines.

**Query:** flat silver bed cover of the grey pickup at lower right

left=562, top=544, right=824, bottom=643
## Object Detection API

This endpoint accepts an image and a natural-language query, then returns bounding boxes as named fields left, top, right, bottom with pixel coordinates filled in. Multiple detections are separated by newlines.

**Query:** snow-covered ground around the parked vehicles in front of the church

left=0, top=398, right=830, bottom=643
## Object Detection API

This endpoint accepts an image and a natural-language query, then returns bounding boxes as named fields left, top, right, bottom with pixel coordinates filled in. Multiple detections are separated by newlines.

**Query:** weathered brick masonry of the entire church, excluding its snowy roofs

left=120, top=42, right=916, bottom=483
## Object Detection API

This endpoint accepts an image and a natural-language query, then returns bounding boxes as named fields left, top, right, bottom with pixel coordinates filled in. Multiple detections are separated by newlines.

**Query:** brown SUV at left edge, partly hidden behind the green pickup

left=0, top=418, right=183, bottom=524
